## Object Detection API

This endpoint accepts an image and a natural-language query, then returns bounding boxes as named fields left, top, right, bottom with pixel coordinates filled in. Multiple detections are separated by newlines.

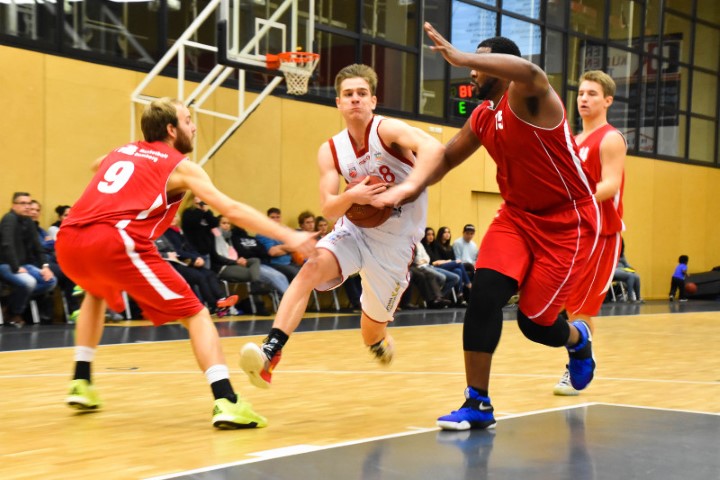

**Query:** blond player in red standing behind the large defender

left=553, top=70, right=627, bottom=395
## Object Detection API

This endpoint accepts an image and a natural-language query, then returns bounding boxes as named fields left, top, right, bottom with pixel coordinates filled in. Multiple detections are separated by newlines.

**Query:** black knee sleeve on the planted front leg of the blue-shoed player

left=463, top=269, right=518, bottom=353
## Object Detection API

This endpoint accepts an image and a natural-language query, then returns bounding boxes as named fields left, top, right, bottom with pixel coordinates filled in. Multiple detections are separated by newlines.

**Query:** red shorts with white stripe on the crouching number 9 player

left=55, top=224, right=204, bottom=325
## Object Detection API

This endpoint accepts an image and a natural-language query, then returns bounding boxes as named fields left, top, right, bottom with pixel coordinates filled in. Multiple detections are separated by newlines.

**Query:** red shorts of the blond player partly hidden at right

left=565, top=232, right=621, bottom=317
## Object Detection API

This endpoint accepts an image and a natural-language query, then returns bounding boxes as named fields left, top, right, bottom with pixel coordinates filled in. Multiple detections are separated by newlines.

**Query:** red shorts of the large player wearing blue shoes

left=475, top=201, right=598, bottom=325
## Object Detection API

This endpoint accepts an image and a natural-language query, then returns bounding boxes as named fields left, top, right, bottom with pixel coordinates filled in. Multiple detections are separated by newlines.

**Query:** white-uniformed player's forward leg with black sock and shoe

left=240, top=249, right=340, bottom=388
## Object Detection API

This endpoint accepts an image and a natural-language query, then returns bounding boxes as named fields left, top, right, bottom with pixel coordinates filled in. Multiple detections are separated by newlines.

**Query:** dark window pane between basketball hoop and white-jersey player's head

left=308, top=30, right=358, bottom=98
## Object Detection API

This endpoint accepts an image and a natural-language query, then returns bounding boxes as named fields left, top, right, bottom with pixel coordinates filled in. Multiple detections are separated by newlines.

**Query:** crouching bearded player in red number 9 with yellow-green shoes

left=56, top=98, right=315, bottom=429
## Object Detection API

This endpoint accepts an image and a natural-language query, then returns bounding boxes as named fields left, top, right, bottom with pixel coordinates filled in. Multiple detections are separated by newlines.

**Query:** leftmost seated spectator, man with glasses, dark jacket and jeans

left=0, top=192, right=57, bottom=327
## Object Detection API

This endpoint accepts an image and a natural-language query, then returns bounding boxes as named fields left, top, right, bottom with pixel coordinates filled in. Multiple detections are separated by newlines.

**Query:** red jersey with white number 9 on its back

left=62, top=142, right=186, bottom=241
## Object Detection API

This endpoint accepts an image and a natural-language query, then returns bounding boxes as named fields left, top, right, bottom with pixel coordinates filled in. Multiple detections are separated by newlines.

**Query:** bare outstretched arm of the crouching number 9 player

left=167, top=159, right=316, bottom=256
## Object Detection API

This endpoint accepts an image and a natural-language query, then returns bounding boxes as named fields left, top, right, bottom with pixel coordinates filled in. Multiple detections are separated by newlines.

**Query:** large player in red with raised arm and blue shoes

left=376, top=23, right=598, bottom=430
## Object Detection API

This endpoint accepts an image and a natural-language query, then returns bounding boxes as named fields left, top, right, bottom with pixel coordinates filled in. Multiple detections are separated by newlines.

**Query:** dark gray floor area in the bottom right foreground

left=152, top=404, right=720, bottom=480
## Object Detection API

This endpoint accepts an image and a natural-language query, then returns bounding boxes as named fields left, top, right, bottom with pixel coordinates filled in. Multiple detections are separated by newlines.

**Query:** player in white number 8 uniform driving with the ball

left=240, top=64, right=444, bottom=388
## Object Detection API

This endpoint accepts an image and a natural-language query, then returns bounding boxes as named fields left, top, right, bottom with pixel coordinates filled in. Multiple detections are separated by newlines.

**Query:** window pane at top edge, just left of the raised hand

left=360, top=0, right=418, bottom=45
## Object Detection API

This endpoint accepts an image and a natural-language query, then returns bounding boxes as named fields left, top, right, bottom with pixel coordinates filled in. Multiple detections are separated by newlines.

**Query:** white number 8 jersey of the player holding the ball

left=329, top=115, right=427, bottom=245
